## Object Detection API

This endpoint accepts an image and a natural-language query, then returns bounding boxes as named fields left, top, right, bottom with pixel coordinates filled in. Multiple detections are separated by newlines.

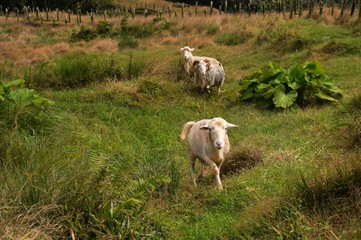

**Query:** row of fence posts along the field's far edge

left=0, top=0, right=361, bottom=24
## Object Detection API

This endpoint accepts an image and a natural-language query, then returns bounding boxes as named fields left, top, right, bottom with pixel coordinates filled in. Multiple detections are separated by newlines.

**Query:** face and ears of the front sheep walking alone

left=200, top=118, right=237, bottom=150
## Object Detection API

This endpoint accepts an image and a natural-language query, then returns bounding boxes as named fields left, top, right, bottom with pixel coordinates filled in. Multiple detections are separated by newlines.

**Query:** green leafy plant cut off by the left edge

left=0, top=79, right=54, bottom=130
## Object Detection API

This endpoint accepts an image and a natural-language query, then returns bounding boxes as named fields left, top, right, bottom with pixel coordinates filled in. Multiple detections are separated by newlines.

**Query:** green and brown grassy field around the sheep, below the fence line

left=0, top=3, right=361, bottom=239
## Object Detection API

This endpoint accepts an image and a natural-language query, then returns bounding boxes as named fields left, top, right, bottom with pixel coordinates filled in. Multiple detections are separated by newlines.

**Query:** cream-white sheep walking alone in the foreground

left=181, top=117, right=237, bottom=189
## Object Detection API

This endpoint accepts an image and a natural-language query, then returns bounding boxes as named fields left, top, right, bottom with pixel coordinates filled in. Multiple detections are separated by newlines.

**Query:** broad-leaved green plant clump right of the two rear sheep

left=239, top=61, right=342, bottom=108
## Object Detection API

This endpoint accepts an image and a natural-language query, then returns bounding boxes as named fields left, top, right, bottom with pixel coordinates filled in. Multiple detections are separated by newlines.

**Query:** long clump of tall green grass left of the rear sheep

left=24, top=53, right=148, bottom=89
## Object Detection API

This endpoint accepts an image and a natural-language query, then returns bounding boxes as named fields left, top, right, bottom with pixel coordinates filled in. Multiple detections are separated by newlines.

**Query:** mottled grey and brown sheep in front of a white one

left=193, top=59, right=225, bottom=96
